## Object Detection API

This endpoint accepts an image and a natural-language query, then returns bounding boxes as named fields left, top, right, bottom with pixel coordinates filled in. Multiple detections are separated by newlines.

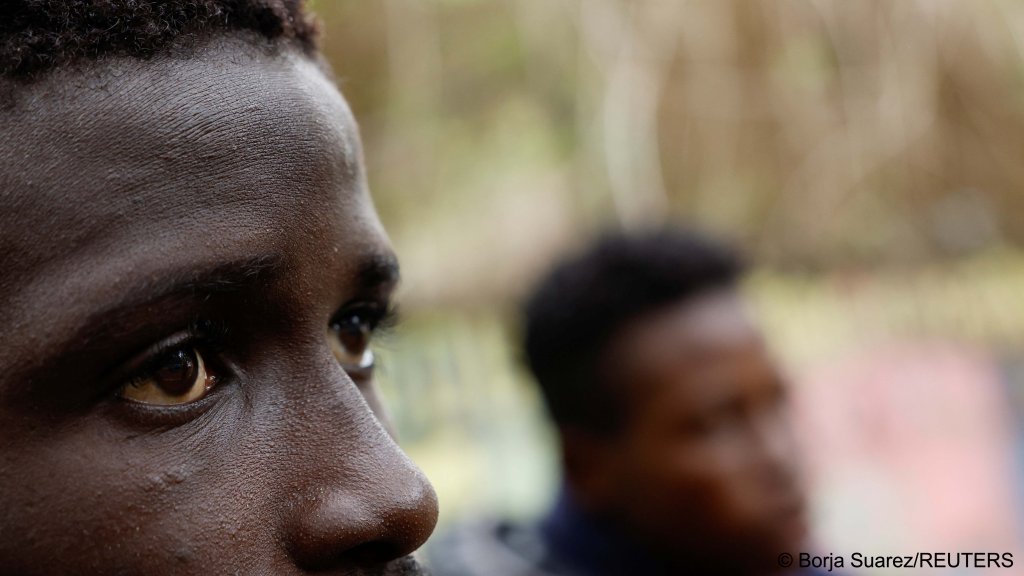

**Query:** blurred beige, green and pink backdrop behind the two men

left=313, top=0, right=1024, bottom=573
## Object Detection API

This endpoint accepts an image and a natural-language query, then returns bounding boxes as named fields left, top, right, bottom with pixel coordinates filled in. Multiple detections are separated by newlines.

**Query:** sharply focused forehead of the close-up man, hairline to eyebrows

left=0, top=38, right=386, bottom=362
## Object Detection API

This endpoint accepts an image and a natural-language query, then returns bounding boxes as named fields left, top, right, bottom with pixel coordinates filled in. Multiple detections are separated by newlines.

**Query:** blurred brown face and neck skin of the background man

left=563, top=290, right=806, bottom=574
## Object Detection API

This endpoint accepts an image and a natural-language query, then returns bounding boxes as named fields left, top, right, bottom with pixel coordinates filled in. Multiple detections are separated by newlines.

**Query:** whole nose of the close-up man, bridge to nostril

left=286, top=366, right=437, bottom=572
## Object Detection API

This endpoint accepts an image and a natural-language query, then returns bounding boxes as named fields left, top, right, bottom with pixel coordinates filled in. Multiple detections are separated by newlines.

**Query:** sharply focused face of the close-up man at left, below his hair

left=0, top=39, right=436, bottom=574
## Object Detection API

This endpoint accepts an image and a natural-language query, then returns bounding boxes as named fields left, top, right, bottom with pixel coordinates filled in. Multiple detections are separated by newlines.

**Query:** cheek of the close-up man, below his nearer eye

left=0, top=399, right=272, bottom=574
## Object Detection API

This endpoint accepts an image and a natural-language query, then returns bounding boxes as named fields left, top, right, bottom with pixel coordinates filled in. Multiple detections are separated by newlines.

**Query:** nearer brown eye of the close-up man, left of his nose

left=119, top=347, right=216, bottom=406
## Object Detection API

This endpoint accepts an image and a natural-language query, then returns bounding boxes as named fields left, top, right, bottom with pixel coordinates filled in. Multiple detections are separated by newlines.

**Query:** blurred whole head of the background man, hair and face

left=524, top=231, right=804, bottom=573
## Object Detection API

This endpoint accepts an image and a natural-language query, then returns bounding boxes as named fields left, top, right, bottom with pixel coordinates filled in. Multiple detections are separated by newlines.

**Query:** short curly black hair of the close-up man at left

left=0, top=0, right=316, bottom=80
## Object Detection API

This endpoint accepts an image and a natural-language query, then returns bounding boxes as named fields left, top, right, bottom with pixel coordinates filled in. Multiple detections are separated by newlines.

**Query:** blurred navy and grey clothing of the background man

left=426, top=493, right=835, bottom=576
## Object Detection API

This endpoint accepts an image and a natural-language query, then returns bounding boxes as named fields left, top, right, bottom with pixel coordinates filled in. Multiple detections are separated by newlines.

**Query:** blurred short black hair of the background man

left=523, top=229, right=745, bottom=433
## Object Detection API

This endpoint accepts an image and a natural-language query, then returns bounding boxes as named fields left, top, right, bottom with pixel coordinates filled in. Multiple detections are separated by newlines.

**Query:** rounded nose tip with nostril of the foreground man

left=290, top=454, right=437, bottom=571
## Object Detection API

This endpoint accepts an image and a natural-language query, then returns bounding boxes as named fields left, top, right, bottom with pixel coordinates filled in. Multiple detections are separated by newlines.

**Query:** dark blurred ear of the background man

left=560, top=426, right=618, bottom=511
